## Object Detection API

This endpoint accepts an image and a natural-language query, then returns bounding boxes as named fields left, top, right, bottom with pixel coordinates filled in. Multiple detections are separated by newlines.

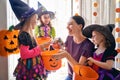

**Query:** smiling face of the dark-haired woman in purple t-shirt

left=67, top=18, right=81, bottom=36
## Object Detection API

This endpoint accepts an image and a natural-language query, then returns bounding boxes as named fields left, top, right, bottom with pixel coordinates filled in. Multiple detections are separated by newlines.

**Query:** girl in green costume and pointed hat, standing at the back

left=35, top=2, right=56, bottom=39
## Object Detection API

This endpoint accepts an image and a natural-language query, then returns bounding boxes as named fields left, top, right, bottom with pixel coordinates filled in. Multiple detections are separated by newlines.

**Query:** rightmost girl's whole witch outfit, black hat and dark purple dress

left=83, top=24, right=119, bottom=80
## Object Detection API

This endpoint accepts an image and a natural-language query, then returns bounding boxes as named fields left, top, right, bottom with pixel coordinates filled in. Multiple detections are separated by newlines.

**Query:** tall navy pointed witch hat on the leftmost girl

left=9, top=0, right=36, bottom=20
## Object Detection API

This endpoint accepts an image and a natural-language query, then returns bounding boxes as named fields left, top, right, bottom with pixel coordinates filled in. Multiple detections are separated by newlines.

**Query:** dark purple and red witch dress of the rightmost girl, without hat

left=92, top=49, right=119, bottom=80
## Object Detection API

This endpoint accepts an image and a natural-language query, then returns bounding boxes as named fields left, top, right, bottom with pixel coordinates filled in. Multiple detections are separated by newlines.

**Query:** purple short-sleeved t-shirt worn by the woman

left=65, top=36, right=94, bottom=76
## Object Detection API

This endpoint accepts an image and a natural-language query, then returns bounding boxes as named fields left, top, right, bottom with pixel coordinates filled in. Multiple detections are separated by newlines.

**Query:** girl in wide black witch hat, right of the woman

left=83, top=24, right=118, bottom=80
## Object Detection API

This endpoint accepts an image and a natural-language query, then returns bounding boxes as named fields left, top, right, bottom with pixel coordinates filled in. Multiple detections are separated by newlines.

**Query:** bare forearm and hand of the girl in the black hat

left=88, top=57, right=114, bottom=70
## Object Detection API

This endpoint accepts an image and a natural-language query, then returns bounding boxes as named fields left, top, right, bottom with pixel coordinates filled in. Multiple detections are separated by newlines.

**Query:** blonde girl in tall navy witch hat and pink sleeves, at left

left=9, top=0, right=49, bottom=80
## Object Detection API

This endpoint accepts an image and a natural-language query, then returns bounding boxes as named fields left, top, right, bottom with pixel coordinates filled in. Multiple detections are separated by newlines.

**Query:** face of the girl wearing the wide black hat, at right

left=92, top=31, right=105, bottom=45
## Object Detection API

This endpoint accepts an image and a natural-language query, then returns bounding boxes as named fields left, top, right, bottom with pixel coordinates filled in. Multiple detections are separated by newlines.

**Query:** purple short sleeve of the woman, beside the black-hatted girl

left=81, top=40, right=94, bottom=58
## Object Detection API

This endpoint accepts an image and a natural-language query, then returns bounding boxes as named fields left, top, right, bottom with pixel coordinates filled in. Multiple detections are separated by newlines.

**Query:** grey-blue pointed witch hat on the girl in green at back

left=38, top=2, right=55, bottom=19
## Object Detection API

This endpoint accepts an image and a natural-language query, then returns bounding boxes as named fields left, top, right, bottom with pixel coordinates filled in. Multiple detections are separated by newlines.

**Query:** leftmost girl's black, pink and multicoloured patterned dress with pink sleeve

left=13, top=32, right=45, bottom=80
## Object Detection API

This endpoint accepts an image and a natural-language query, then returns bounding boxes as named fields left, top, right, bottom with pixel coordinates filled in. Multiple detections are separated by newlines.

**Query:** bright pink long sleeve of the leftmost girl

left=20, top=44, right=41, bottom=59
